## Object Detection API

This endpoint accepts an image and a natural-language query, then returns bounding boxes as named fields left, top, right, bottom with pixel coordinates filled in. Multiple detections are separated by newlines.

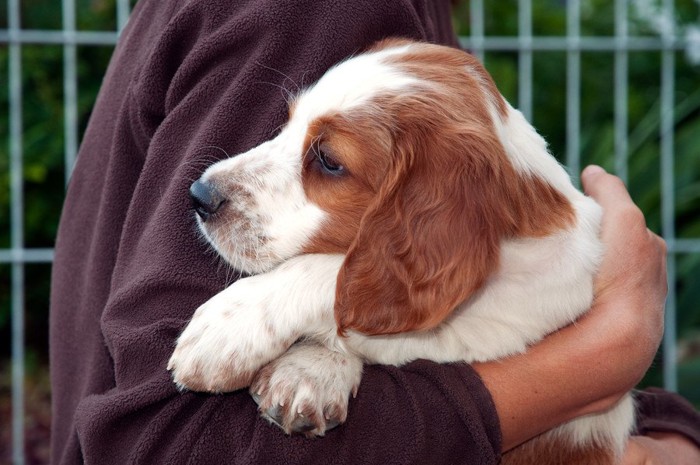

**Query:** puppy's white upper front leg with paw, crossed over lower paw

left=168, top=255, right=344, bottom=392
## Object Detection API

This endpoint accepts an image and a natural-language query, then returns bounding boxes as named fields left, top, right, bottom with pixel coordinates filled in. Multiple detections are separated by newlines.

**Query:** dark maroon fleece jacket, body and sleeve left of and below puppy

left=51, top=0, right=500, bottom=465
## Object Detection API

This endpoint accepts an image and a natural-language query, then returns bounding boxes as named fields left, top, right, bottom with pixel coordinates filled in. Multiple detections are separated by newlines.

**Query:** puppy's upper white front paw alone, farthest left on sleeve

left=168, top=278, right=296, bottom=393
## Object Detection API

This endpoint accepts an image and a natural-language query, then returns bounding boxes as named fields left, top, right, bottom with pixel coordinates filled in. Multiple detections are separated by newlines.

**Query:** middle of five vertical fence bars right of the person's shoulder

left=566, top=0, right=581, bottom=185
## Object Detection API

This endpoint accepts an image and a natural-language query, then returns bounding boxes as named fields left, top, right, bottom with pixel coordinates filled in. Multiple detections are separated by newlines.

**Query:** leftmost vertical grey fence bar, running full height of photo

left=7, top=0, right=25, bottom=465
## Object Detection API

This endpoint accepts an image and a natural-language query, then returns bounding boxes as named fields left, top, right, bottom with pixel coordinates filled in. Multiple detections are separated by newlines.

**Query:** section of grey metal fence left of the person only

left=0, top=0, right=130, bottom=465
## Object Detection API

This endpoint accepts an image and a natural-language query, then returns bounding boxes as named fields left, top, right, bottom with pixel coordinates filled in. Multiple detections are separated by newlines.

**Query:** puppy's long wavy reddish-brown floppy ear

left=335, top=131, right=515, bottom=335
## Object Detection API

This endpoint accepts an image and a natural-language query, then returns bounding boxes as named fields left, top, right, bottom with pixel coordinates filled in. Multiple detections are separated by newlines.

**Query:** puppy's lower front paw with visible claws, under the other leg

left=250, top=342, right=362, bottom=437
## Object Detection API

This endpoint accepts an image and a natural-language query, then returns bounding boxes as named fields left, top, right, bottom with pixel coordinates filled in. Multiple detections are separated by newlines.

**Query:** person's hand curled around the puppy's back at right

left=581, top=166, right=667, bottom=408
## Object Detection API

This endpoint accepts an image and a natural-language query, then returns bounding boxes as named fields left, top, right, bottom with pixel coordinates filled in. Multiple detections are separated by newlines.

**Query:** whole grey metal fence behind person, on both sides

left=0, top=0, right=700, bottom=464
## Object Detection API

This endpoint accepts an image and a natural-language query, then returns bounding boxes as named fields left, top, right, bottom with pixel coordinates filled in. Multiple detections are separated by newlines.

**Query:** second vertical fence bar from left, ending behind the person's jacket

left=62, top=0, right=78, bottom=184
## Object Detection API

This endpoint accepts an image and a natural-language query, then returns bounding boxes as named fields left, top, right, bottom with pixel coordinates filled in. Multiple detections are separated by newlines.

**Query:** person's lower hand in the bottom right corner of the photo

left=620, top=433, right=700, bottom=465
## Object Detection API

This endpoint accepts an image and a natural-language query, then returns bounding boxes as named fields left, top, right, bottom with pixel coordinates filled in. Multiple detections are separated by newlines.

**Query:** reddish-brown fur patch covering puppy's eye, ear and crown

left=303, top=42, right=574, bottom=334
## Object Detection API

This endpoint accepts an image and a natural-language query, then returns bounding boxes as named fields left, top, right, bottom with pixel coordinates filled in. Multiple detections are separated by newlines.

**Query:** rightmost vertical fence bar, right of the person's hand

left=660, top=0, right=678, bottom=391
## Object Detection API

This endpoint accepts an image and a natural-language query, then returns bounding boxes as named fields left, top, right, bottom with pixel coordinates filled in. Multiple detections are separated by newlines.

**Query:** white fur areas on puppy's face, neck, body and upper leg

left=169, top=41, right=633, bottom=451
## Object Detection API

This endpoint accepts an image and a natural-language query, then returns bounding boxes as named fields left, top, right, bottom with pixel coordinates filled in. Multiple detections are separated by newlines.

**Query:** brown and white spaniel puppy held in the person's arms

left=168, top=39, right=634, bottom=464
